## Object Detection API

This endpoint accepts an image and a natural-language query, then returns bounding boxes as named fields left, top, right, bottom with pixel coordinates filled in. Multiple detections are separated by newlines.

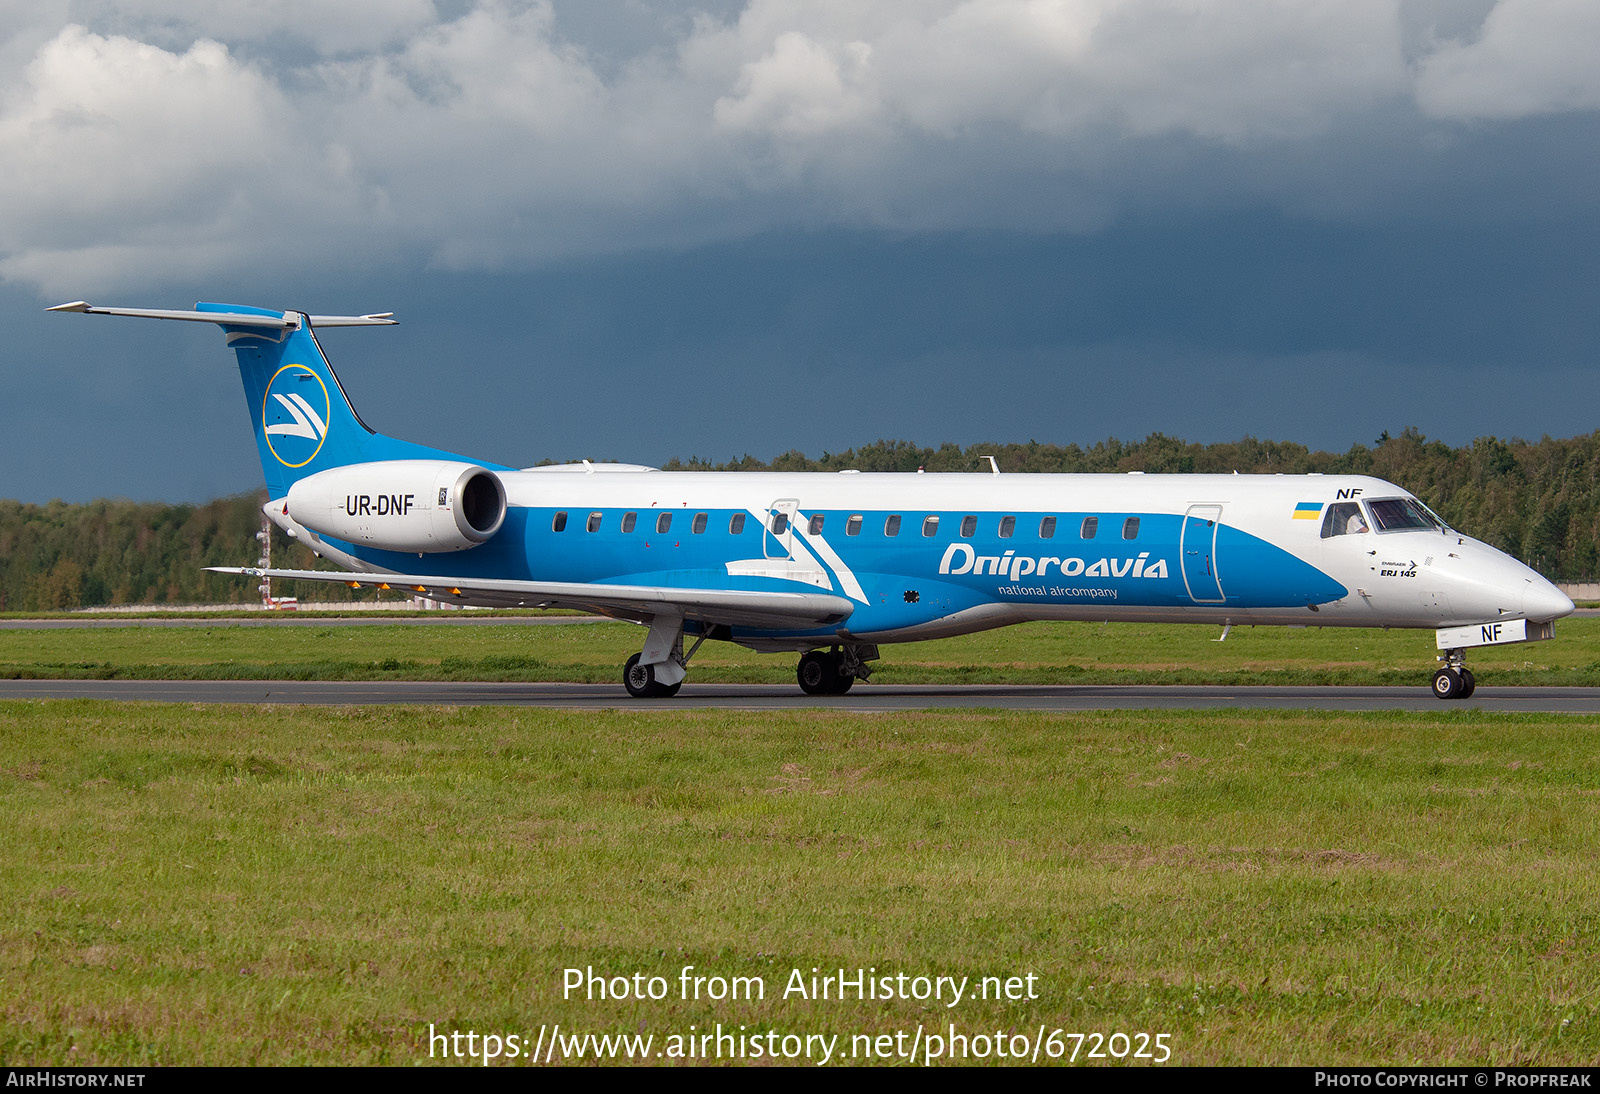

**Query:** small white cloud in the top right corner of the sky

left=1416, top=0, right=1600, bottom=118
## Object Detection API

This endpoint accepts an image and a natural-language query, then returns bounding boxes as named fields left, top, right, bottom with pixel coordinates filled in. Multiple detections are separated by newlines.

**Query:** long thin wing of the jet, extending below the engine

left=219, top=566, right=854, bottom=629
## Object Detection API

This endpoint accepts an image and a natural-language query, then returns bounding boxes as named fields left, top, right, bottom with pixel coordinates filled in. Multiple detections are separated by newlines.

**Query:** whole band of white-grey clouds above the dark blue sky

left=0, top=0, right=1600, bottom=293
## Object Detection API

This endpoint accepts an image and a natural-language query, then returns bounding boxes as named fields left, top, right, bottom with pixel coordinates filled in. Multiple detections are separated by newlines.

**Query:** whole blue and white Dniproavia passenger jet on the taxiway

left=51, top=301, right=1573, bottom=699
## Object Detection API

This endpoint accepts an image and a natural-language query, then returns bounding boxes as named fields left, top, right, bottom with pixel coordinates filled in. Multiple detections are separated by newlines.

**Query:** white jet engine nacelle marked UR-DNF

left=285, top=459, right=506, bottom=552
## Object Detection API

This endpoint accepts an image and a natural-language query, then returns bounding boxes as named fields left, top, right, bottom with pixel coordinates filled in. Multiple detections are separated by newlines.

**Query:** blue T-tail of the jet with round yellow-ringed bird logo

left=50, top=301, right=493, bottom=499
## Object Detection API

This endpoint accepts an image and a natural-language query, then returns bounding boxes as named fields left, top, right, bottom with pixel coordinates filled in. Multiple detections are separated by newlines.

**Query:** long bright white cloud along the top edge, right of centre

left=714, top=0, right=1406, bottom=141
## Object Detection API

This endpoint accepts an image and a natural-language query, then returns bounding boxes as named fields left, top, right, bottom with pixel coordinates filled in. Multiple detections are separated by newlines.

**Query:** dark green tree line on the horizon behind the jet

left=0, top=429, right=1600, bottom=611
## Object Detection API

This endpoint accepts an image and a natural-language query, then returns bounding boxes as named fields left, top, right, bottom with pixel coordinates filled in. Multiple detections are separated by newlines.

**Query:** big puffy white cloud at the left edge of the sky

left=0, top=26, right=380, bottom=286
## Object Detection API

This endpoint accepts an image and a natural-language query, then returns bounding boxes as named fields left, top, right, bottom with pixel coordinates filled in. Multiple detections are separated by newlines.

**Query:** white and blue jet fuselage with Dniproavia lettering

left=328, top=465, right=1571, bottom=649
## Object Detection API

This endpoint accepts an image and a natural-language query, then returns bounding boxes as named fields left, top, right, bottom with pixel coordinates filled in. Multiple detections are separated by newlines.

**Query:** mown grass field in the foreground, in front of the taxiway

left=0, top=697, right=1600, bottom=1064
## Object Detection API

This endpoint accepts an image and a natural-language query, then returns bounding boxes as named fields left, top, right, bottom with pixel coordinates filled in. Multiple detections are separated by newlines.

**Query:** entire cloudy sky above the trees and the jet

left=0, top=0, right=1600, bottom=501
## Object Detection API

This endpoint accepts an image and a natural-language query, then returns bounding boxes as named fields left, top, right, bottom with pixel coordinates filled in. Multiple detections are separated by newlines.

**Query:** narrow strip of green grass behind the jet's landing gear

left=0, top=617, right=1600, bottom=686
